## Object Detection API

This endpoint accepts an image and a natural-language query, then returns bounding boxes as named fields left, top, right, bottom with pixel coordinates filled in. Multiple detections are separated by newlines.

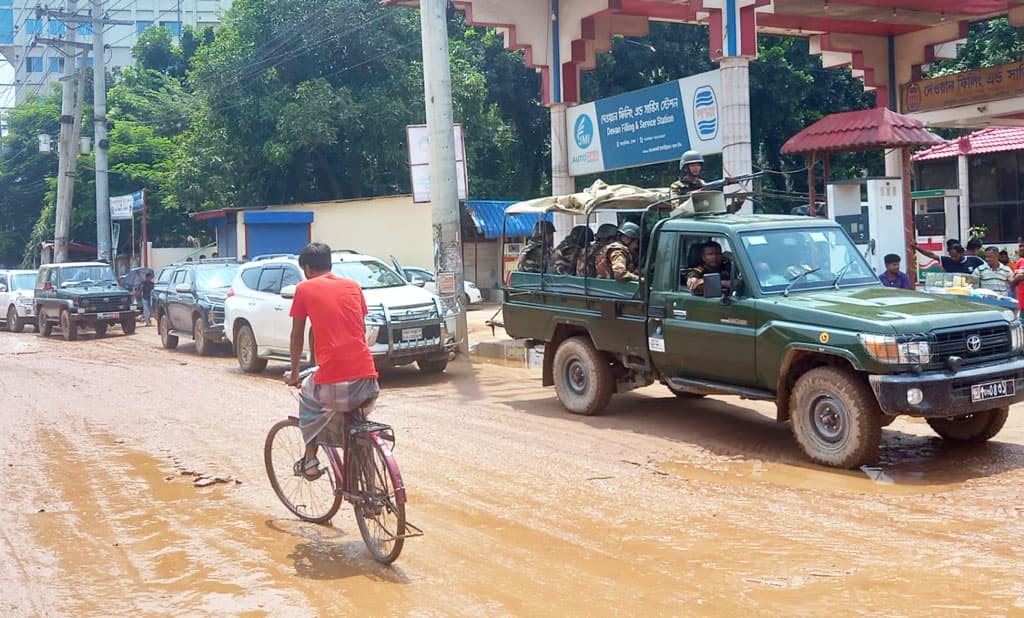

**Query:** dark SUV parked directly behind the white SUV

left=151, top=259, right=239, bottom=356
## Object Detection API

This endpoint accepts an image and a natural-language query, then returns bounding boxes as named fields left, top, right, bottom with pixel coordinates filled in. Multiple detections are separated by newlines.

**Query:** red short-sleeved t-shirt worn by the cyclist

left=291, top=272, right=377, bottom=384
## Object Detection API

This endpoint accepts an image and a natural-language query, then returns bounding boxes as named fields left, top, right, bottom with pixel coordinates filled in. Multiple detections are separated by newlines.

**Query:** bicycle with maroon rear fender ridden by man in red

left=263, top=367, right=423, bottom=564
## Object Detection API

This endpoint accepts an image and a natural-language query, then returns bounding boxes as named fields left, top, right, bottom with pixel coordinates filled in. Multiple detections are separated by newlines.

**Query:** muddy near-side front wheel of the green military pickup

left=790, top=367, right=882, bottom=469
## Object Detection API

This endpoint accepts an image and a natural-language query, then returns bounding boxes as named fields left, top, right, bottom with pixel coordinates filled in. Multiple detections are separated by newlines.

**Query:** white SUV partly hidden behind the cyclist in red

left=224, top=251, right=456, bottom=372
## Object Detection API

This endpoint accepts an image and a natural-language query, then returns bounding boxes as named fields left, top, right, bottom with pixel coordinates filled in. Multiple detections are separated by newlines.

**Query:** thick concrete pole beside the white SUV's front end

left=420, top=0, right=469, bottom=353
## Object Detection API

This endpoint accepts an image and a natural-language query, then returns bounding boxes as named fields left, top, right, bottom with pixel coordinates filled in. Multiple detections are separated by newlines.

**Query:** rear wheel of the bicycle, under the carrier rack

left=350, top=437, right=406, bottom=565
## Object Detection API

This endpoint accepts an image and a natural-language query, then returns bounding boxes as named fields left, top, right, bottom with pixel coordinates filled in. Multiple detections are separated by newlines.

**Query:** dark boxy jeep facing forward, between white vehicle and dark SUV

left=35, top=262, right=135, bottom=341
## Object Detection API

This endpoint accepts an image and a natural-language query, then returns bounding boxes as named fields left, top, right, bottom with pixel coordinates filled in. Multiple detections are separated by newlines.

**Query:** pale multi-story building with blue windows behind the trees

left=0, top=0, right=231, bottom=101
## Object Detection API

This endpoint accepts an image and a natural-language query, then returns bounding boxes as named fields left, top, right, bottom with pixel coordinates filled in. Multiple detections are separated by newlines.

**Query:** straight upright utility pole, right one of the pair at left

left=92, top=0, right=113, bottom=263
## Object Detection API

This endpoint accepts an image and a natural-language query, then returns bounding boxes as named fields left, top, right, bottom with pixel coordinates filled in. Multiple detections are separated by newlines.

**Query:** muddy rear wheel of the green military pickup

left=554, top=337, right=615, bottom=415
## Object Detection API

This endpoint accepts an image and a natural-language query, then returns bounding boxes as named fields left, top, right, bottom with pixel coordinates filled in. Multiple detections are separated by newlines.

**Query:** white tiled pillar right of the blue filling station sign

left=719, top=56, right=754, bottom=213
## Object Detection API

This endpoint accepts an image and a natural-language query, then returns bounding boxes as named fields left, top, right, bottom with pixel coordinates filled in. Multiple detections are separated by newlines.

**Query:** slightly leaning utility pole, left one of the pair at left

left=53, top=0, right=81, bottom=264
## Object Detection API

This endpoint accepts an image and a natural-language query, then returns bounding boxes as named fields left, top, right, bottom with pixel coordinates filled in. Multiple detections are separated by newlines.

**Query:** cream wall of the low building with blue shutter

left=237, top=195, right=434, bottom=270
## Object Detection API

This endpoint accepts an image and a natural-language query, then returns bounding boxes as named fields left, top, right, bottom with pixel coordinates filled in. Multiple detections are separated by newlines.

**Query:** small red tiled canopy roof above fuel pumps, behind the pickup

left=782, top=107, right=944, bottom=155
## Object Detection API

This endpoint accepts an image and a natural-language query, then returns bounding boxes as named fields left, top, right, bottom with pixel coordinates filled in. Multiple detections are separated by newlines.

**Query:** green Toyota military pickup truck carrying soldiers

left=503, top=187, right=1024, bottom=468
